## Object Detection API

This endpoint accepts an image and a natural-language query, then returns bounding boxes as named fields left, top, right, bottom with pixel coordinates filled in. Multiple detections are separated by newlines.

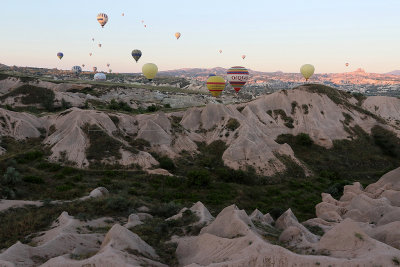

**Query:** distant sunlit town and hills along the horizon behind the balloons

left=0, top=64, right=400, bottom=97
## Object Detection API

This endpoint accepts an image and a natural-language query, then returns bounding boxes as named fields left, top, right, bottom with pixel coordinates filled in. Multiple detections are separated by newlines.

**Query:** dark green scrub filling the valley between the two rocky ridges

left=0, top=122, right=400, bottom=250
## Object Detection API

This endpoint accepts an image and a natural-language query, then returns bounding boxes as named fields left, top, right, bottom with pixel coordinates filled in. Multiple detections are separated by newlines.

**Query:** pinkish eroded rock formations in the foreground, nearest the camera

left=0, top=169, right=400, bottom=267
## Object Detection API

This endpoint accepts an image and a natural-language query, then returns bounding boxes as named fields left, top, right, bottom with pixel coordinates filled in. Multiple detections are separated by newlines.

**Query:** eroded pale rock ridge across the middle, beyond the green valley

left=0, top=78, right=400, bottom=176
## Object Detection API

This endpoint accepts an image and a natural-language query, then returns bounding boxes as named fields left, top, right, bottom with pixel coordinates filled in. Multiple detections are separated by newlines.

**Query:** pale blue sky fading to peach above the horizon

left=0, top=0, right=400, bottom=73
